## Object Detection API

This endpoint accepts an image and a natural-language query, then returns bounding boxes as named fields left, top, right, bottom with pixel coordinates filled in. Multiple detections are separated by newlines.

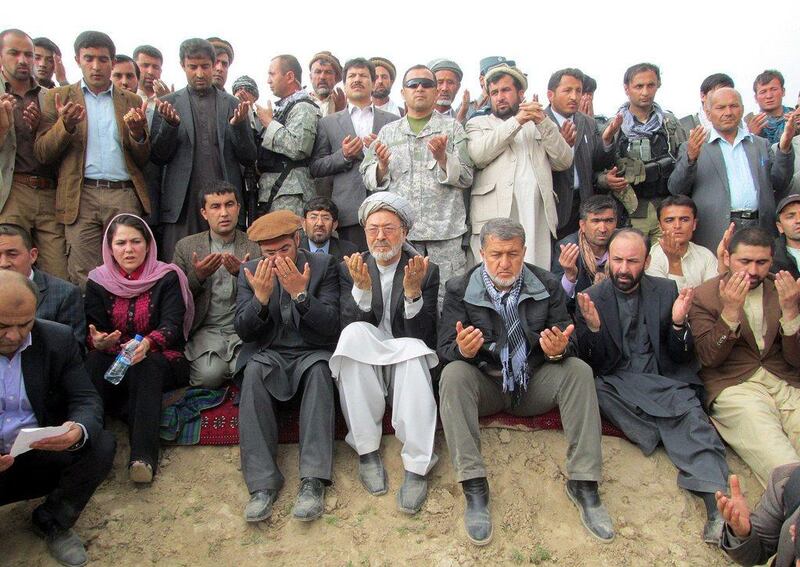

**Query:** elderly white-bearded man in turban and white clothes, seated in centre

left=330, top=191, right=439, bottom=514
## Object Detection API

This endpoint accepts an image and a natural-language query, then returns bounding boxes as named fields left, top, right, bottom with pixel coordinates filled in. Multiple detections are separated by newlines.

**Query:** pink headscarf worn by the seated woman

left=89, top=213, right=194, bottom=339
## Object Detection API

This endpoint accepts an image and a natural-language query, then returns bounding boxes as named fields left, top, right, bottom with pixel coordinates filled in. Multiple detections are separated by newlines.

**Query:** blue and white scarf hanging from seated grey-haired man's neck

left=481, top=266, right=528, bottom=405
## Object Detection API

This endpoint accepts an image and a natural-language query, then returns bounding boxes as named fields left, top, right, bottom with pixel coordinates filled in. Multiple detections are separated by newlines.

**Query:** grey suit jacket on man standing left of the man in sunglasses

left=310, top=107, right=400, bottom=226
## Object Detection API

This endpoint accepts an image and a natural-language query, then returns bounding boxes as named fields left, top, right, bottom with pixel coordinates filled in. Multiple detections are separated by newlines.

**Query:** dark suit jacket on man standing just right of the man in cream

left=546, top=106, right=616, bottom=238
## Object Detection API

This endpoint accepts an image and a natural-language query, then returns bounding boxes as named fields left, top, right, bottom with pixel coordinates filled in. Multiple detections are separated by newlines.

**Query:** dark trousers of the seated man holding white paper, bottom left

left=0, top=431, right=116, bottom=534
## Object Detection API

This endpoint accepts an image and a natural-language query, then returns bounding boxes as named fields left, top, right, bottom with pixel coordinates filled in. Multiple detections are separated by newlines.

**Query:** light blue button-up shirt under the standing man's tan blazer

left=81, top=79, right=131, bottom=181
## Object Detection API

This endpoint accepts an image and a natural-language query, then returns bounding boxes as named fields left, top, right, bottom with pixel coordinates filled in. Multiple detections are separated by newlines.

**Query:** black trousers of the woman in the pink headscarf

left=86, top=350, right=189, bottom=471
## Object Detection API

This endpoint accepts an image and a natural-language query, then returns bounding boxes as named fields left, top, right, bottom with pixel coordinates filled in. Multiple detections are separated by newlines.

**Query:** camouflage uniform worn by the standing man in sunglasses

left=360, top=112, right=472, bottom=307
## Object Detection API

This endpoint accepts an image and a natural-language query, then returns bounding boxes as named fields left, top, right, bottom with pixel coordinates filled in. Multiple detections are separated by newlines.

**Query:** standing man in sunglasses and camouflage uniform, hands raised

left=360, top=65, right=472, bottom=307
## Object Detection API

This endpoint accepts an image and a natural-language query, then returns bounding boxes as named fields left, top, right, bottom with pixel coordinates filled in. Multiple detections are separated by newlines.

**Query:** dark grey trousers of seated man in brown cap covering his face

left=239, top=361, right=336, bottom=494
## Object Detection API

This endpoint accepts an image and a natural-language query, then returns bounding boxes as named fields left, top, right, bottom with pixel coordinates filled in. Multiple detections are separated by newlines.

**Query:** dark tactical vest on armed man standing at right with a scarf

left=617, top=112, right=686, bottom=199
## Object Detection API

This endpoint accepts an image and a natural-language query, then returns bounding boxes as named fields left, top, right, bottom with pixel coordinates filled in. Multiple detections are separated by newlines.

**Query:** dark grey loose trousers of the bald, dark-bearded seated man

left=595, top=378, right=729, bottom=492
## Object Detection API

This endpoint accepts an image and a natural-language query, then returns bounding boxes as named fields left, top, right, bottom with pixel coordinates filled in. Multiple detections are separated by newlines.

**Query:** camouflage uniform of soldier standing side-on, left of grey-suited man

left=258, top=91, right=320, bottom=217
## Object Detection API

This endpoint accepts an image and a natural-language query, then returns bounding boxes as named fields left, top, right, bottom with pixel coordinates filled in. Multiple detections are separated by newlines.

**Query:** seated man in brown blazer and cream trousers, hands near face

left=689, top=227, right=800, bottom=486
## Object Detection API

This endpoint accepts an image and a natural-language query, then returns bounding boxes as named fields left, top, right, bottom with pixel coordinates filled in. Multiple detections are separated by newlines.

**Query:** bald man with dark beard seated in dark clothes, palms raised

left=576, top=229, right=728, bottom=543
